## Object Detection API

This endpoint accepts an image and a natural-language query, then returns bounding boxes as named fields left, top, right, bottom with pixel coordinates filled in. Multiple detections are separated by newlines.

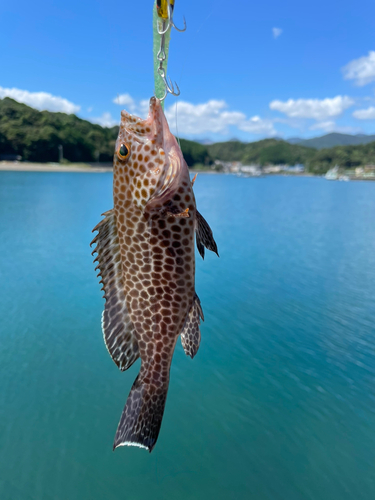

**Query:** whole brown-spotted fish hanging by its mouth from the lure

left=91, top=97, right=219, bottom=452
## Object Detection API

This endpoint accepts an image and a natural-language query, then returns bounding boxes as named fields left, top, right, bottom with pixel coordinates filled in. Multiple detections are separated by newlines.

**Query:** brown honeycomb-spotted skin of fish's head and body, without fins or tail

left=113, top=99, right=196, bottom=376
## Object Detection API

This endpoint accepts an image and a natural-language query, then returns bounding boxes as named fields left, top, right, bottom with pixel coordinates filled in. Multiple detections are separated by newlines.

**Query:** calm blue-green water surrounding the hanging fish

left=0, top=172, right=375, bottom=500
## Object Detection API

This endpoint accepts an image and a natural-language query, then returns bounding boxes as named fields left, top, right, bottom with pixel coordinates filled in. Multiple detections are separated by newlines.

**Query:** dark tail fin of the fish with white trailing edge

left=113, top=375, right=169, bottom=453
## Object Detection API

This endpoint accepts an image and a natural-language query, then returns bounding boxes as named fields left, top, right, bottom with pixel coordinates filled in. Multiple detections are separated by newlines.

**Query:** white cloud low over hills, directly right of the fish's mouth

left=165, top=100, right=276, bottom=136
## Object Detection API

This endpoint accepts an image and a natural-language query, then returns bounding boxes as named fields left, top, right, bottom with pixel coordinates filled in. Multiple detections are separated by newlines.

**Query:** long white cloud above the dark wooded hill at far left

left=0, top=87, right=81, bottom=114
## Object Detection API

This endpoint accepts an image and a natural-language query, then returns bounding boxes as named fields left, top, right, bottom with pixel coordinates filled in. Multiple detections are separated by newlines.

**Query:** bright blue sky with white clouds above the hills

left=0, top=0, right=375, bottom=141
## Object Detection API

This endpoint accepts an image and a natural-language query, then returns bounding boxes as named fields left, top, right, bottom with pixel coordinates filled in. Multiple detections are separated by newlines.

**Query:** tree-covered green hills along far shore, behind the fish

left=0, top=97, right=375, bottom=174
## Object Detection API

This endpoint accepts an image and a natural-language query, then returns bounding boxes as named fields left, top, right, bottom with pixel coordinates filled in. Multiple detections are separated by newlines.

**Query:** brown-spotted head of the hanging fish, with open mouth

left=114, top=97, right=189, bottom=209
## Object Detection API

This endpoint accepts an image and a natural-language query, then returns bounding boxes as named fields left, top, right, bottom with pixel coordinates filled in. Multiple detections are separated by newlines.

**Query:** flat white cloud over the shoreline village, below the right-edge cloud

left=270, top=95, right=354, bottom=120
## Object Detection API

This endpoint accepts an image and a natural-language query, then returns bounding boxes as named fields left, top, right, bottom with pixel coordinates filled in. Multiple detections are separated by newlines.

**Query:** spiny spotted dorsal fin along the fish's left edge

left=91, top=209, right=139, bottom=370
